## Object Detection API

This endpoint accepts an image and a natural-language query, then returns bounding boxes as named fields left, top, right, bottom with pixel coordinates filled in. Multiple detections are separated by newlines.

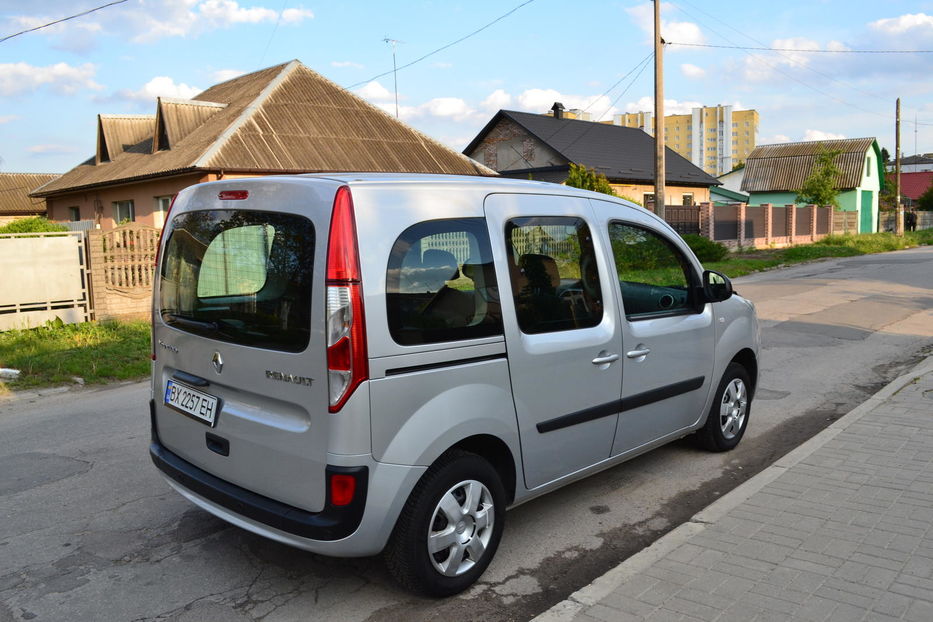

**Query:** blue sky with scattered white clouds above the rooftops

left=0, top=0, right=933, bottom=172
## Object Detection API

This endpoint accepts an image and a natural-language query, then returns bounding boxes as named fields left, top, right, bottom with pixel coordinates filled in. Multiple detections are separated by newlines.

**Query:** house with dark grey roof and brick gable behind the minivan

left=463, top=103, right=719, bottom=205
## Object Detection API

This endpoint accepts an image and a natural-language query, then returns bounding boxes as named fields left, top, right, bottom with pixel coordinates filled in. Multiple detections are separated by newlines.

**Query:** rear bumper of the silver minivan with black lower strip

left=149, top=402, right=425, bottom=557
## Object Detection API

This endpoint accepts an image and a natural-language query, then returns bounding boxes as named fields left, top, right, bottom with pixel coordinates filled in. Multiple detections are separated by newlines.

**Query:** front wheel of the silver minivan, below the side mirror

left=696, top=362, right=752, bottom=451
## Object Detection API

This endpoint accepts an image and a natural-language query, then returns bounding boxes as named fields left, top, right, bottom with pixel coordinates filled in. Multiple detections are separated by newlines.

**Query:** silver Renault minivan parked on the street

left=150, top=174, right=759, bottom=595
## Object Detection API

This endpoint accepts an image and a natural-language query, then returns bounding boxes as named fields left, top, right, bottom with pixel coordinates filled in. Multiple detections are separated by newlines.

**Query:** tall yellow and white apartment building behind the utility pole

left=612, top=106, right=758, bottom=176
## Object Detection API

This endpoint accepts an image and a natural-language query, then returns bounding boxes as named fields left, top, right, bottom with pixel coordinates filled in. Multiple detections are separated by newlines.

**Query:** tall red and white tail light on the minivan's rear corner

left=327, top=186, right=369, bottom=413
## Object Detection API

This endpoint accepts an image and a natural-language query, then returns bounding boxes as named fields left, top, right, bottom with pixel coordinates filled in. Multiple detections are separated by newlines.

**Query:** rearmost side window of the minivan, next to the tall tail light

left=386, top=218, right=502, bottom=346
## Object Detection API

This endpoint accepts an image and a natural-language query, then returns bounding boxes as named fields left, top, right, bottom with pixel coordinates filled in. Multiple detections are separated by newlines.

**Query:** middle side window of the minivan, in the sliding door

left=505, top=216, right=603, bottom=334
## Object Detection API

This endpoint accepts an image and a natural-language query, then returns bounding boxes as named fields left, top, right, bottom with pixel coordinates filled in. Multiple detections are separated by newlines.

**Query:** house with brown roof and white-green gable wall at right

left=742, top=138, right=884, bottom=233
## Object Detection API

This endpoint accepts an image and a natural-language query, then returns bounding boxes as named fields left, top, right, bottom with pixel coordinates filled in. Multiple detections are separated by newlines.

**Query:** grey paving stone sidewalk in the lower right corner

left=536, top=357, right=933, bottom=622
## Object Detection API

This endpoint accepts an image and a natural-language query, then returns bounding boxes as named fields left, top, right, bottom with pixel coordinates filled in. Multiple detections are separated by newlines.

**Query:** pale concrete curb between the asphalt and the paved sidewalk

left=533, top=355, right=933, bottom=622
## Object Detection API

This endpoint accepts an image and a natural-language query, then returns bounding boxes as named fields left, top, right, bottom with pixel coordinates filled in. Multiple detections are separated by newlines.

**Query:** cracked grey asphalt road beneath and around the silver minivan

left=0, top=247, right=933, bottom=622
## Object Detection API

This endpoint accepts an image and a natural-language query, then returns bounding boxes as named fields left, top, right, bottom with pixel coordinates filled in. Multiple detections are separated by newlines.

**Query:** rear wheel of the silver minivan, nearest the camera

left=385, top=450, right=506, bottom=597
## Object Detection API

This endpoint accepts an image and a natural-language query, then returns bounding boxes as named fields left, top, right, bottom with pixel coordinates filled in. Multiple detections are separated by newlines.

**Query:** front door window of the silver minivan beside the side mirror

left=609, top=222, right=696, bottom=321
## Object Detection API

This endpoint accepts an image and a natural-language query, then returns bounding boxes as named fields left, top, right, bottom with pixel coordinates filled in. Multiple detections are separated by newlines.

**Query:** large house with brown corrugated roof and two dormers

left=31, top=61, right=495, bottom=229
